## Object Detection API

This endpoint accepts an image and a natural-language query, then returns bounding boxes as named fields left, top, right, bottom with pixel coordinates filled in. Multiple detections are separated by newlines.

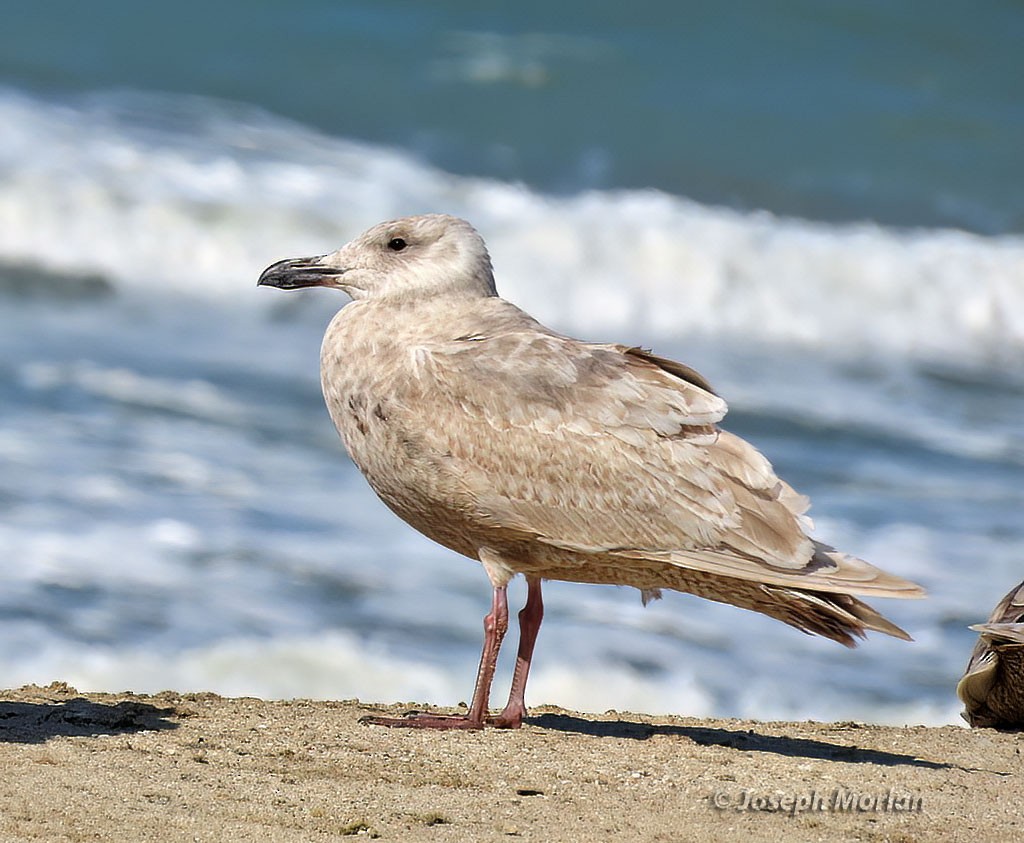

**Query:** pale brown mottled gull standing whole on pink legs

left=259, top=214, right=924, bottom=728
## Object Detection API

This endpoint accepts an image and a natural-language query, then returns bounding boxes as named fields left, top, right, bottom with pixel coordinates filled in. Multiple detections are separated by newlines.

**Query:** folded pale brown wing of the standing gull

left=405, top=326, right=924, bottom=597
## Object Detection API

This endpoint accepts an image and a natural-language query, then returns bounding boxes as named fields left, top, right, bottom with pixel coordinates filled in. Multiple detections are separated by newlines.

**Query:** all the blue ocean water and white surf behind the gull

left=0, top=2, right=1024, bottom=723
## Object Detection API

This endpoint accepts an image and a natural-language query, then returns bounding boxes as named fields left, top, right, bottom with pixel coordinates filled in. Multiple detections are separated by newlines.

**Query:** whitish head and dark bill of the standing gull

left=257, top=214, right=497, bottom=302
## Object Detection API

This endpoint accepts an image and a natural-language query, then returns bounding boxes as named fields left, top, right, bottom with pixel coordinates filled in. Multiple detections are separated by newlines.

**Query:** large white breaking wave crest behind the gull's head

left=0, top=90, right=1024, bottom=365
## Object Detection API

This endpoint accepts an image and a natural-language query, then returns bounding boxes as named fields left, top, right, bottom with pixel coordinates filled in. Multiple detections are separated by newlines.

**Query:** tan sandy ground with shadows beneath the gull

left=0, top=682, right=1024, bottom=841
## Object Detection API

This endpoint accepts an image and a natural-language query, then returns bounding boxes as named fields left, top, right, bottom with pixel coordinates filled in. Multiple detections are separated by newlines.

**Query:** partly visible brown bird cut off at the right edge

left=956, top=583, right=1024, bottom=729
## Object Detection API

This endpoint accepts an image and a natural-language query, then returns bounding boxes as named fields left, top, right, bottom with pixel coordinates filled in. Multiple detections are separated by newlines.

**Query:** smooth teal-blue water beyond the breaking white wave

left=8, top=0, right=1024, bottom=234
